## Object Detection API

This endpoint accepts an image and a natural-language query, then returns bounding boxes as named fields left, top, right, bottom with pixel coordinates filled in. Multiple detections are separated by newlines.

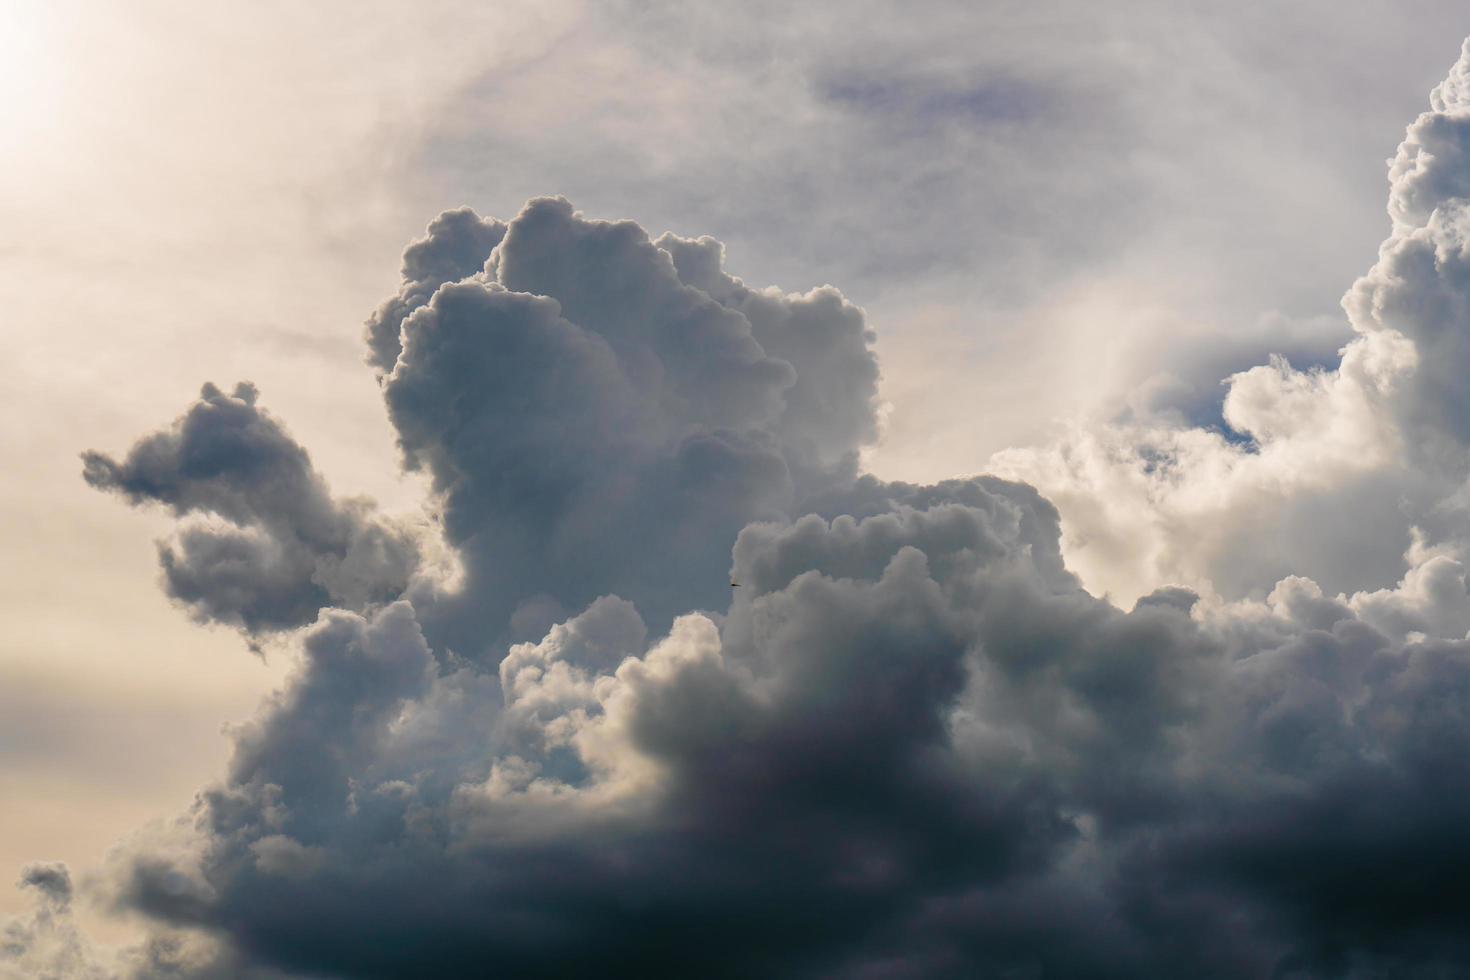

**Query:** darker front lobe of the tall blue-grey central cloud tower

left=387, top=274, right=791, bottom=644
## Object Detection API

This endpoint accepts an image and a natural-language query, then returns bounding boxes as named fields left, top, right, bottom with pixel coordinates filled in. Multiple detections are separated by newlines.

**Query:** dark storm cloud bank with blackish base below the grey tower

left=103, top=485, right=1470, bottom=977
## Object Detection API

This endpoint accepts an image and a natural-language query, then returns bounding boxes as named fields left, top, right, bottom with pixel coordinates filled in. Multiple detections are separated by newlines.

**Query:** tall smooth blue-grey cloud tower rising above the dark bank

left=384, top=198, right=878, bottom=643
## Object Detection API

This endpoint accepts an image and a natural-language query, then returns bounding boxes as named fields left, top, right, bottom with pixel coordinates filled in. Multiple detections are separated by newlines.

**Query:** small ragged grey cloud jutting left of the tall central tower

left=82, top=383, right=417, bottom=635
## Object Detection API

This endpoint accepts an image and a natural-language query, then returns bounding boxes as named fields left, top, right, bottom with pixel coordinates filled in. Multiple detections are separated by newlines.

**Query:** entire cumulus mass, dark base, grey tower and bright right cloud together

left=25, top=38, right=1470, bottom=979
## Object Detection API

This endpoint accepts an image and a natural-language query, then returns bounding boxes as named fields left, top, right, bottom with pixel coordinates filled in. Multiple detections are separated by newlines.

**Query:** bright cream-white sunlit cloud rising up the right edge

left=992, top=38, right=1470, bottom=598
